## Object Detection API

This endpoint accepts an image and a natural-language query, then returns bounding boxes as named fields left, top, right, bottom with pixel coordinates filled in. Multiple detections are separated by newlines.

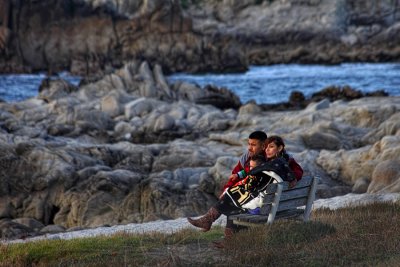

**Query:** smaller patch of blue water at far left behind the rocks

left=0, top=73, right=80, bottom=102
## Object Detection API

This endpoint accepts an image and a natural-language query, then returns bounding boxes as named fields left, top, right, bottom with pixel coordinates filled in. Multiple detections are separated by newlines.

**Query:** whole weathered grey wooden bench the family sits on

left=227, top=171, right=319, bottom=226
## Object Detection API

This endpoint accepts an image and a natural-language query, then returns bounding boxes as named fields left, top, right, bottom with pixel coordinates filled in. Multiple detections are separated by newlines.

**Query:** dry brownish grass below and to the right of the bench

left=223, top=204, right=400, bottom=266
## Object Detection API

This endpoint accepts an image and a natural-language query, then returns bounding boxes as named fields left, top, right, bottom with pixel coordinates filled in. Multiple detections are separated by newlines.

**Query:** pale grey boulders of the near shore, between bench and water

left=0, top=62, right=400, bottom=239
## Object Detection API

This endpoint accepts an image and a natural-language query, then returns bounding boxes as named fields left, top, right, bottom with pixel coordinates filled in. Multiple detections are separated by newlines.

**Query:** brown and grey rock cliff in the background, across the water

left=0, top=0, right=400, bottom=74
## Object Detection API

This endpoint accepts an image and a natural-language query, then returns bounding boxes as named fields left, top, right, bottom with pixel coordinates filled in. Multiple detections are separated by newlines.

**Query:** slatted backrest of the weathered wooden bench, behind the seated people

left=261, top=171, right=319, bottom=223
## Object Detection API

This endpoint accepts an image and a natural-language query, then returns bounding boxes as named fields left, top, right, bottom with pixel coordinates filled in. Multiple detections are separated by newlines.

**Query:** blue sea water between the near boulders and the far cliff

left=0, top=63, right=400, bottom=104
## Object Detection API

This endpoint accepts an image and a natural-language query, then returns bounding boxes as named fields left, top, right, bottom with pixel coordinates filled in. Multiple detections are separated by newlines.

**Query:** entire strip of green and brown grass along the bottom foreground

left=0, top=203, right=400, bottom=266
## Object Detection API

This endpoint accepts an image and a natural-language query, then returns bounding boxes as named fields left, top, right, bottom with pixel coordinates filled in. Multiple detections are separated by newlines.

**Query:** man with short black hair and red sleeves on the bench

left=221, top=131, right=267, bottom=196
